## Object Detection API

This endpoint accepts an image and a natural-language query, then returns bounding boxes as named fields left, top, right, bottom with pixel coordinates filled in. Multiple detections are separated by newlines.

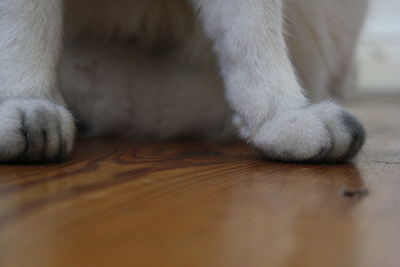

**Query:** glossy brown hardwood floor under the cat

left=0, top=98, right=400, bottom=267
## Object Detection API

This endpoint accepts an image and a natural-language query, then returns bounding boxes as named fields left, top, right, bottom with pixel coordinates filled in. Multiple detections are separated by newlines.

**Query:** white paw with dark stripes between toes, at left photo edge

left=0, top=99, right=75, bottom=163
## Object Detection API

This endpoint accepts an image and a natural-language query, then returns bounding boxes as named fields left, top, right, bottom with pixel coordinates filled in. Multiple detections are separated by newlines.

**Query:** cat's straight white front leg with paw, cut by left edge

left=0, top=0, right=74, bottom=163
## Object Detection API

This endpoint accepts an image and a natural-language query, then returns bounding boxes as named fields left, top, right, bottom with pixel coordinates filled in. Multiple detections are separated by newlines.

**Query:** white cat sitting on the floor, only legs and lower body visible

left=0, top=0, right=367, bottom=162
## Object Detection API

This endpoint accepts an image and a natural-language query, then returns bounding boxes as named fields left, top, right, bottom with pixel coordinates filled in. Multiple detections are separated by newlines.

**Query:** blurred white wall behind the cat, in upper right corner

left=356, top=0, right=400, bottom=95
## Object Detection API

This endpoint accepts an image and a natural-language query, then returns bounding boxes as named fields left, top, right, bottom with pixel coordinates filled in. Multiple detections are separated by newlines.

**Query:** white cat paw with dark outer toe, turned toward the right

left=244, top=102, right=365, bottom=163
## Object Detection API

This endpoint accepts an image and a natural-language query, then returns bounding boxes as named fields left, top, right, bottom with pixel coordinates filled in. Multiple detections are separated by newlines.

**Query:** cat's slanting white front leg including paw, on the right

left=192, top=0, right=365, bottom=162
